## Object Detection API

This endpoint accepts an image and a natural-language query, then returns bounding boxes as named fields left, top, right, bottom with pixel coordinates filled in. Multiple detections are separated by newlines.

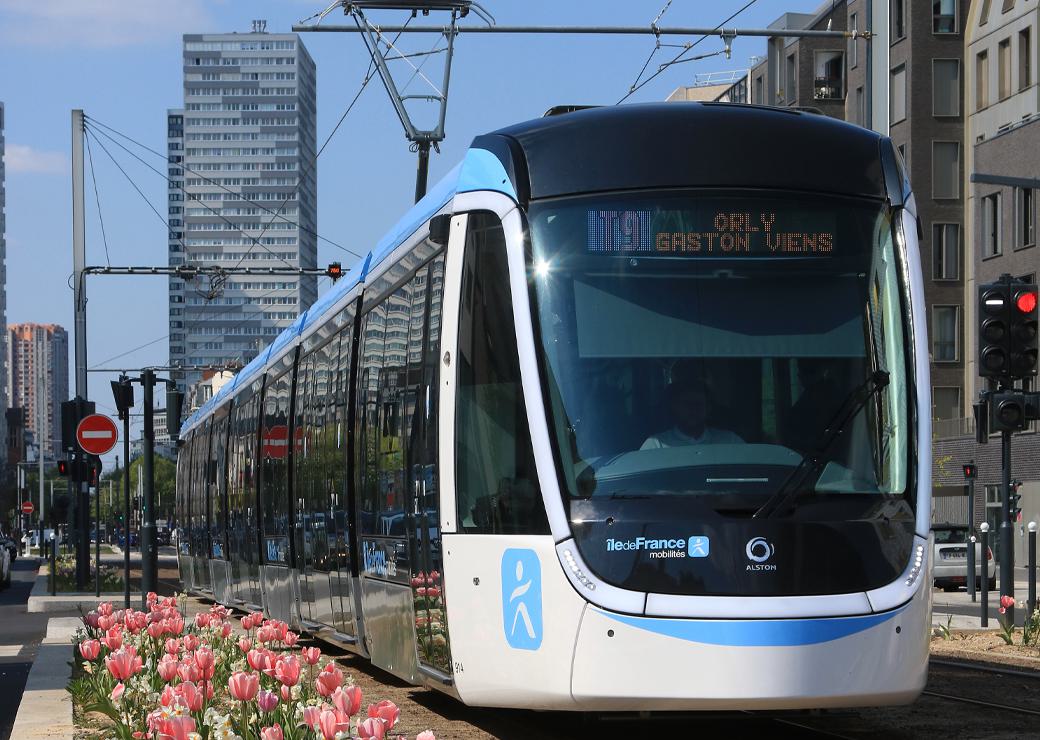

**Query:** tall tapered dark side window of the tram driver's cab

left=456, top=213, right=549, bottom=534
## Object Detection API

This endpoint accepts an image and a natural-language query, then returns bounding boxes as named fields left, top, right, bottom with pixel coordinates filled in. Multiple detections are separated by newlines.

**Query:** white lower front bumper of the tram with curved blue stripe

left=571, top=588, right=930, bottom=711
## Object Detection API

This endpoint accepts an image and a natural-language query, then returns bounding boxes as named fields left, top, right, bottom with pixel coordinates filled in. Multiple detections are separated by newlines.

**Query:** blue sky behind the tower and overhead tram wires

left=0, top=0, right=820, bottom=457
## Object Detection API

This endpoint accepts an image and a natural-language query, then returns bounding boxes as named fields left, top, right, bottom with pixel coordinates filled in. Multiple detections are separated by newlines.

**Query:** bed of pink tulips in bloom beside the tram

left=69, top=593, right=435, bottom=740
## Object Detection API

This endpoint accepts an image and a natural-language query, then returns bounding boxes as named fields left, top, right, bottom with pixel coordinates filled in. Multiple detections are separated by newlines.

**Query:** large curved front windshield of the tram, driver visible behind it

left=528, top=191, right=913, bottom=519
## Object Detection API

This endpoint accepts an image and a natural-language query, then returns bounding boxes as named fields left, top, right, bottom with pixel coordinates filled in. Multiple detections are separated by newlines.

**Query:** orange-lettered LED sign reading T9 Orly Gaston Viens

left=589, top=209, right=835, bottom=257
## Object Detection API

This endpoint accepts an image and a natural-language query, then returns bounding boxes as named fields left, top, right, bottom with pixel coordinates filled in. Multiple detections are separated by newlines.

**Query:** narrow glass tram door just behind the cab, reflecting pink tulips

left=404, top=255, right=451, bottom=675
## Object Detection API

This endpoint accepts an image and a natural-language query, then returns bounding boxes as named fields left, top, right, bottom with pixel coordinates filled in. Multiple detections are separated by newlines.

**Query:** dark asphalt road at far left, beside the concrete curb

left=0, top=557, right=75, bottom=740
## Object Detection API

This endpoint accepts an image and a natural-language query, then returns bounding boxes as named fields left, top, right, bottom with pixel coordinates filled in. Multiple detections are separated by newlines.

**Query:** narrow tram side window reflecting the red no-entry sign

left=261, top=372, right=292, bottom=563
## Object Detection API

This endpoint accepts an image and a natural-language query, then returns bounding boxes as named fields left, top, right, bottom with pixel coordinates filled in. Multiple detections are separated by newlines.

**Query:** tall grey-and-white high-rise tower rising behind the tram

left=166, top=22, right=317, bottom=391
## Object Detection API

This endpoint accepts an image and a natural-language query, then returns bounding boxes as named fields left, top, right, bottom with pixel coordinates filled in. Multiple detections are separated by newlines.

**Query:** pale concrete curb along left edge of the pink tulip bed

left=10, top=617, right=80, bottom=740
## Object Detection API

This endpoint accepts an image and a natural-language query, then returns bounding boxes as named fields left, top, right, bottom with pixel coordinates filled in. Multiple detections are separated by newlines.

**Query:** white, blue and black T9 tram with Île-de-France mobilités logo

left=177, top=103, right=931, bottom=711
